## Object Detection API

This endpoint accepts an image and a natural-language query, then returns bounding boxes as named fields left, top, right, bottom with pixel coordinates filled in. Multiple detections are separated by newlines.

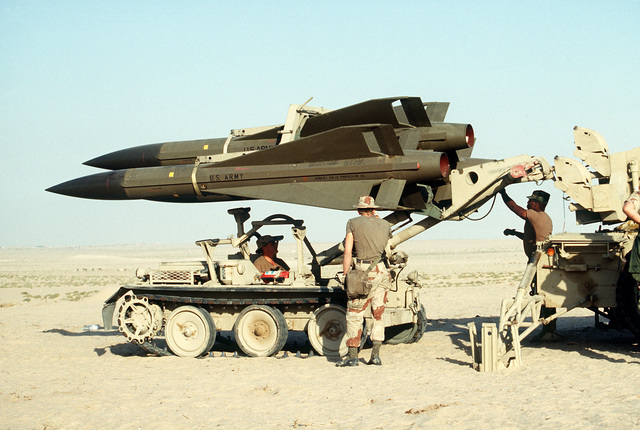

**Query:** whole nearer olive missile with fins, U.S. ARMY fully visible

left=47, top=124, right=450, bottom=210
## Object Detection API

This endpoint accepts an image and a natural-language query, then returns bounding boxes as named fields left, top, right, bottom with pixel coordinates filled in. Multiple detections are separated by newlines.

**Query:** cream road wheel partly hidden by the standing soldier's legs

left=307, top=304, right=348, bottom=357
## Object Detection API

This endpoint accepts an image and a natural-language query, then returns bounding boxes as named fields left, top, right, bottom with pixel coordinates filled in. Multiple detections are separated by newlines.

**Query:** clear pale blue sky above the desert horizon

left=0, top=0, right=640, bottom=247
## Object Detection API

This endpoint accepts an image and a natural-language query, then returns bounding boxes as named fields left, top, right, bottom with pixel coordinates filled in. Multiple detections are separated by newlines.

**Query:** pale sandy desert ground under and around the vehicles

left=0, top=239, right=640, bottom=429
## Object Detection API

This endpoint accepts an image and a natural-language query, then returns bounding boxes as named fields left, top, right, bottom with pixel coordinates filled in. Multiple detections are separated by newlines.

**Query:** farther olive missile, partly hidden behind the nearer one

left=84, top=97, right=475, bottom=170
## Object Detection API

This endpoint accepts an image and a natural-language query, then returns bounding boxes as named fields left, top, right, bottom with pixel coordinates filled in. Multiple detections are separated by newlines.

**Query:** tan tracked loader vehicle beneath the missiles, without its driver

left=102, top=208, right=426, bottom=357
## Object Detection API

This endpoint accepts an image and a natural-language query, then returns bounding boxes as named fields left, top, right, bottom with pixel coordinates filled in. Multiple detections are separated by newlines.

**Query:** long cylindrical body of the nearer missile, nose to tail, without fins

left=47, top=152, right=449, bottom=197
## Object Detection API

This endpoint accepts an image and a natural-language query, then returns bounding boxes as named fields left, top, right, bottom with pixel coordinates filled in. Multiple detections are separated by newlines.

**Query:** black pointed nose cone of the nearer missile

left=46, top=171, right=128, bottom=200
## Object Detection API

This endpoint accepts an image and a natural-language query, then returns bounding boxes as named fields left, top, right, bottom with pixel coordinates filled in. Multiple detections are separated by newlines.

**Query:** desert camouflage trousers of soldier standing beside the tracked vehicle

left=347, top=263, right=391, bottom=347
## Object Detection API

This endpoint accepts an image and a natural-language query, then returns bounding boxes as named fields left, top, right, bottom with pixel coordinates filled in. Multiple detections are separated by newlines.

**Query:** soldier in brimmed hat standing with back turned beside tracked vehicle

left=337, top=196, right=391, bottom=367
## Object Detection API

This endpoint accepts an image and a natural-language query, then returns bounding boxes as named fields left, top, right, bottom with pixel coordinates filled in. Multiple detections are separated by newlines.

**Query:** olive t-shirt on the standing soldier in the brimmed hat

left=347, top=215, right=391, bottom=260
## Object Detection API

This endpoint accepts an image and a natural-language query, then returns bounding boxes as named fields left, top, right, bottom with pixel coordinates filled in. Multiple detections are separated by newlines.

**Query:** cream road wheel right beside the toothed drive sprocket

left=164, top=306, right=216, bottom=357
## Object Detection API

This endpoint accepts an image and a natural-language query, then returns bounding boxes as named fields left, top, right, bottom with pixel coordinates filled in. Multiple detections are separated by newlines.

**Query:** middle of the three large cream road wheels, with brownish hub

left=233, top=305, right=289, bottom=357
